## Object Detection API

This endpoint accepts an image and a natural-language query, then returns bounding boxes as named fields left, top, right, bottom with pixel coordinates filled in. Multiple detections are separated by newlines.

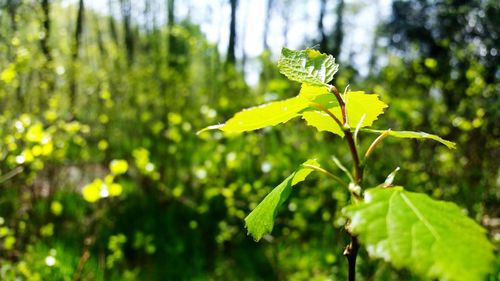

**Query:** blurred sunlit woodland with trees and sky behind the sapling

left=0, top=0, right=500, bottom=280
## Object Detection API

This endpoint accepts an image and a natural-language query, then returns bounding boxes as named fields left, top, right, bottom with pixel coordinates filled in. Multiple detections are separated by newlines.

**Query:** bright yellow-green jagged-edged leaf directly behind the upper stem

left=299, top=91, right=387, bottom=137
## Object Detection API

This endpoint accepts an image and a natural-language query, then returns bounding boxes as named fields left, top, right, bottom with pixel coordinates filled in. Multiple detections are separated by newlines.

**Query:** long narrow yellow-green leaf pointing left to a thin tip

left=198, top=96, right=309, bottom=133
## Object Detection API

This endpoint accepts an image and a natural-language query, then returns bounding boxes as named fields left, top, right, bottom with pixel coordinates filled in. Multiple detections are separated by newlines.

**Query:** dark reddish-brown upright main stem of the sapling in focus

left=329, top=85, right=363, bottom=281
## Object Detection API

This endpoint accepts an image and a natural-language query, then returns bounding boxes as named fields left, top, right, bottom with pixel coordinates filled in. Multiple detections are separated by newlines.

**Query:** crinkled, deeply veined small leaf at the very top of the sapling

left=278, top=48, right=339, bottom=86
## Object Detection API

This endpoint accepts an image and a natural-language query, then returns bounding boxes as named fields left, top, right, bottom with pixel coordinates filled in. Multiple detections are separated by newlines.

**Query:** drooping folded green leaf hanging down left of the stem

left=245, top=160, right=319, bottom=241
